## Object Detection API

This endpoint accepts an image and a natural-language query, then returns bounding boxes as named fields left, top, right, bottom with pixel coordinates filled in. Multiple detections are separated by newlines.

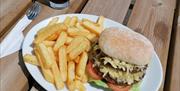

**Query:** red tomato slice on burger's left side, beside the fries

left=86, top=61, right=102, bottom=80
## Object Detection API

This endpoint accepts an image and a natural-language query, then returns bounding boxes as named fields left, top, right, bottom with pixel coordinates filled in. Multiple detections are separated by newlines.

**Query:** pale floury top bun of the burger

left=99, top=27, right=154, bottom=65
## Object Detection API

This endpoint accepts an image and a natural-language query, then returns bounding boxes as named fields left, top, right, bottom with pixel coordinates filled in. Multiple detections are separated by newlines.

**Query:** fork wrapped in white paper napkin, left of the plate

left=0, top=1, right=41, bottom=58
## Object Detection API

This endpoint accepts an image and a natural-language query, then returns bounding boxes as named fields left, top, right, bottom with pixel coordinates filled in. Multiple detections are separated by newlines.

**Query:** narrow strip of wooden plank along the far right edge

left=166, top=3, right=180, bottom=91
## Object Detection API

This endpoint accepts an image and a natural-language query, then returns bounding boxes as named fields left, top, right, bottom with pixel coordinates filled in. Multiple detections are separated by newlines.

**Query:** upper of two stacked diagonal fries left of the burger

left=67, top=36, right=84, bottom=53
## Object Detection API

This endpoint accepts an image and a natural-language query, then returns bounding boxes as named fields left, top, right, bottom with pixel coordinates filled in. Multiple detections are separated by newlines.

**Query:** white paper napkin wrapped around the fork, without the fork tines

left=0, top=15, right=32, bottom=58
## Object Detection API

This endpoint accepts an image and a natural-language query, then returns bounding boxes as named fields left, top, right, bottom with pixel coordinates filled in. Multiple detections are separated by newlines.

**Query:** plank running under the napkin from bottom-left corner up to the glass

left=0, top=0, right=86, bottom=91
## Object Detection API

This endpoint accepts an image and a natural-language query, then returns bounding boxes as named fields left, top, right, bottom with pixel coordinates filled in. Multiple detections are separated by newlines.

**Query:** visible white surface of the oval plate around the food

left=22, top=14, right=162, bottom=91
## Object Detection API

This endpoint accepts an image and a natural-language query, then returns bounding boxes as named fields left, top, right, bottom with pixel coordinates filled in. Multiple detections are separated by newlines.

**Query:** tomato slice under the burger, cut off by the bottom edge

left=107, top=83, right=130, bottom=91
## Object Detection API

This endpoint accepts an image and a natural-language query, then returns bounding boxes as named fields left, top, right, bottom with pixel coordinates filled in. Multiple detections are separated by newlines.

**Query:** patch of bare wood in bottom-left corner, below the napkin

left=0, top=52, right=29, bottom=91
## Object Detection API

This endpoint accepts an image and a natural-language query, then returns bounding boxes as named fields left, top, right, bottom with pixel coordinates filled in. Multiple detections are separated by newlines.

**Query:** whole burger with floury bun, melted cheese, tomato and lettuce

left=87, top=27, right=154, bottom=91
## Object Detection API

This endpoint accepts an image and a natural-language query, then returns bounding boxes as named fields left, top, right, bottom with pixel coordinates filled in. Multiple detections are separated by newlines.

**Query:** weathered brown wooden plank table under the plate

left=0, top=0, right=180, bottom=91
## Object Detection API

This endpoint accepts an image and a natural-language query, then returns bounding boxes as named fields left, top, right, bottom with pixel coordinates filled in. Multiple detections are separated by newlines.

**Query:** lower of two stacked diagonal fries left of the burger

left=68, top=42, right=87, bottom=60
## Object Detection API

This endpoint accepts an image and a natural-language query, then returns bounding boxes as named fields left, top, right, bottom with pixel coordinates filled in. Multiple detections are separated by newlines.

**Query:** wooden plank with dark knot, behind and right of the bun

left=128, top=0, right=176, bottom=91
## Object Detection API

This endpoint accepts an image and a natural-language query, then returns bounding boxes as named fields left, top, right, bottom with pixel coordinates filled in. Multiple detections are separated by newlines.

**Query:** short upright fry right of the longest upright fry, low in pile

left=67, top=61, right=75, bottom=82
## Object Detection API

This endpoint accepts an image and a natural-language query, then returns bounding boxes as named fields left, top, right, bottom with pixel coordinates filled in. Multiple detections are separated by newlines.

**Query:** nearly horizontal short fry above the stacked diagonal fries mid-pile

left=67, top=27, right=89, bottom=37
